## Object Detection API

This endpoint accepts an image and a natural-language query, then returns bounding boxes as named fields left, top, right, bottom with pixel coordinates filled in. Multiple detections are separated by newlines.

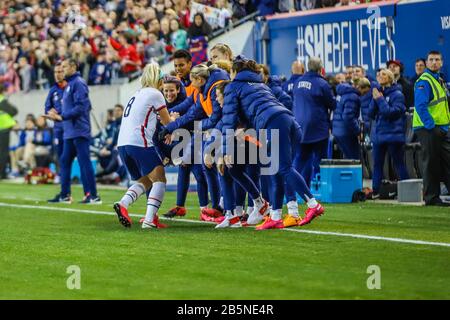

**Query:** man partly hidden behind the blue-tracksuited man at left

left=45, top=62, right=67, bottom=163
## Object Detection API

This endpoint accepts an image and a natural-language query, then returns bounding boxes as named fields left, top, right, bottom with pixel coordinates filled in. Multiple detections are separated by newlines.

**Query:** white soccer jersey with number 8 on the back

left=117, top=88, right=166, bottom=147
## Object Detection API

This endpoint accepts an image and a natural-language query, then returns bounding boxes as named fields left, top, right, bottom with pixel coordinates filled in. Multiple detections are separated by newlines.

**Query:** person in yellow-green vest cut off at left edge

left=0, top=83, right=17, bottom=179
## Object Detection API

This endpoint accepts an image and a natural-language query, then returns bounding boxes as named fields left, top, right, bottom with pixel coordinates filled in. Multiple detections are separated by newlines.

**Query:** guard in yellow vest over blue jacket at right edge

left=413, top=51, right=450, bottom=206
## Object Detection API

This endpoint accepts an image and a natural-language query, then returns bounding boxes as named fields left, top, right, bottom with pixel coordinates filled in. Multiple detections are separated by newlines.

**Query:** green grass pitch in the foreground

left=0, top=183, right=450, bottom=299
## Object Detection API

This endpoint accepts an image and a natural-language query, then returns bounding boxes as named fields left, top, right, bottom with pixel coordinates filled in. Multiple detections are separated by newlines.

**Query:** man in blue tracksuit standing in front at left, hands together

left=47, top=59, right=102, bottom=204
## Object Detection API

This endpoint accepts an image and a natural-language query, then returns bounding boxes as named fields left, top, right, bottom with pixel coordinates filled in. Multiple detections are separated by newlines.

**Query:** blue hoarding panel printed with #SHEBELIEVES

left=267, top=0, right=450, bottom=76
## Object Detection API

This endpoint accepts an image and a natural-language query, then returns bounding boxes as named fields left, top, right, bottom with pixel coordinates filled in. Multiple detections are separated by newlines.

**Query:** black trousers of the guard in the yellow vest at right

left=416, top=127, right=450, bottom=204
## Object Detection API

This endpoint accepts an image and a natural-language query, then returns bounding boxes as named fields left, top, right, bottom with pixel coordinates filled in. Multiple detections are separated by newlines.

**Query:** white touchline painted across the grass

left=0, top=202, right=450, bottom=247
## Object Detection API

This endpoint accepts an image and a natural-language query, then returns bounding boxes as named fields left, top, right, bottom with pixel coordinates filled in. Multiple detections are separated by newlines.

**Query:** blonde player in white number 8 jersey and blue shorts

left=114, top=64, right=170, bottom=229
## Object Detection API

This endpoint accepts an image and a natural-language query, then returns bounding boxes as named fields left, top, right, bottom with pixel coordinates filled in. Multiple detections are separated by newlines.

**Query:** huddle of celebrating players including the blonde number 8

left=114, top=44, right=324, bottom=230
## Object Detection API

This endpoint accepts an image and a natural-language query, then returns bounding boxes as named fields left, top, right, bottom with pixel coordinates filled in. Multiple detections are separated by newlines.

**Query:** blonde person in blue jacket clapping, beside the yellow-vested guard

left=369, top=69, right=409, bottom=199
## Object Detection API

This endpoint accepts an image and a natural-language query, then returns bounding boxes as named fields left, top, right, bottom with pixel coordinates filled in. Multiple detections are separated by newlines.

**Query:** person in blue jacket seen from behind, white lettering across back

left=293, top=57, right=336, bottom=186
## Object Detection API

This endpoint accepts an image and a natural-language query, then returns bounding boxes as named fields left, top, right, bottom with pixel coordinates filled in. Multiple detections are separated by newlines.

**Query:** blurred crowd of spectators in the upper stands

left=0, top=0, right=388, bottom=94
